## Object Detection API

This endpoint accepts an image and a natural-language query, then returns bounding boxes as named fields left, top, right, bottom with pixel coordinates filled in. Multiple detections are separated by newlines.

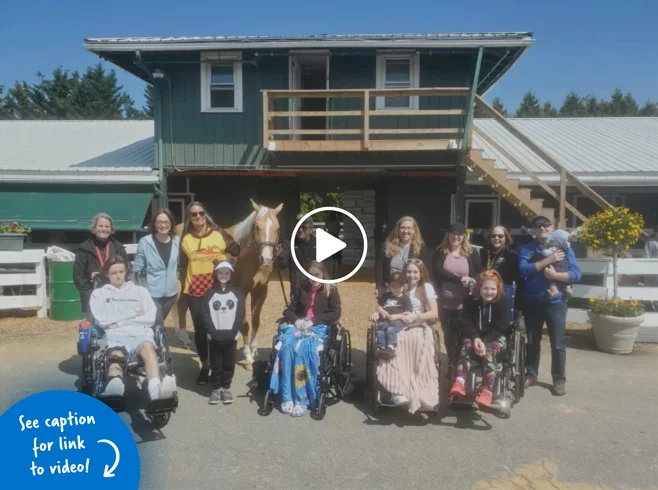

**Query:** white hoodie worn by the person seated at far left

left=89, top=281, right=157, bottom=337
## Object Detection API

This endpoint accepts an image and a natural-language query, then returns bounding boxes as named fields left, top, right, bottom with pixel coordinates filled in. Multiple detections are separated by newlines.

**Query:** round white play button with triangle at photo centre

left=290, top=206, right=368, bottom=284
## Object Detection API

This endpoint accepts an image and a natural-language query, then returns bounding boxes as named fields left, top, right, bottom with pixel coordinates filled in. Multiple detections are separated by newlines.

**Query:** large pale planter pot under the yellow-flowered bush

left=590, top=313, right=644, bottom=354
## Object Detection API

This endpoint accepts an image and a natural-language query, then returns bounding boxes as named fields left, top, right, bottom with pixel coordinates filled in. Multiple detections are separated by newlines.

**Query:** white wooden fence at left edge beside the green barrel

left=0, top=250, right=48, bottom=318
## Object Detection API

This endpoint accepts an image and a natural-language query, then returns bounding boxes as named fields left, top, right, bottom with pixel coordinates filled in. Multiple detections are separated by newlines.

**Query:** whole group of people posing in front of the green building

left=74, top=202, right=580, bottom=416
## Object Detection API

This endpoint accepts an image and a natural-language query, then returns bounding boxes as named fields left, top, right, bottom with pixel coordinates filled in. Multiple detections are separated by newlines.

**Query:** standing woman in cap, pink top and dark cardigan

left=432, top=223, right=482, bottom=362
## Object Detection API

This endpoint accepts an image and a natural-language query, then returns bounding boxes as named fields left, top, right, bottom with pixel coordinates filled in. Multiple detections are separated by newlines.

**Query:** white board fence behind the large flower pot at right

left=567, top=258, right=658, bottom=343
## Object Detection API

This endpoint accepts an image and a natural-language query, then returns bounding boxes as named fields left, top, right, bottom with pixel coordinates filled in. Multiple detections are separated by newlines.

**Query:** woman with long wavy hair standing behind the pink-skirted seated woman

left=375, top=216, right=430, bottom=297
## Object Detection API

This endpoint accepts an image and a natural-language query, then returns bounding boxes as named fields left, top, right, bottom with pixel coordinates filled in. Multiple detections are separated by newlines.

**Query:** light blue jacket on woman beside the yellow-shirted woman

left=133, top=235, right=180, bottom=298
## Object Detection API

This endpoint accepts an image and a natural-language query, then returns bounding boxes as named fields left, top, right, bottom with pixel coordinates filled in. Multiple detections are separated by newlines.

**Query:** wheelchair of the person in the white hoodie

left=77, top=325, right=178, bottom=428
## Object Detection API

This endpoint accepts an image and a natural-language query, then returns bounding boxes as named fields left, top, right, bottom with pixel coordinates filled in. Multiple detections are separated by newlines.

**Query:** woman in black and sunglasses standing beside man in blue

left=481, top=226, right=523, bottom=309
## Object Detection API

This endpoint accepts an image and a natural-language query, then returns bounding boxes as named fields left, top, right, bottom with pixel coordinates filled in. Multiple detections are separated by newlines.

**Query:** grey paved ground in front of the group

left=0, top=333, right=658, bottom=490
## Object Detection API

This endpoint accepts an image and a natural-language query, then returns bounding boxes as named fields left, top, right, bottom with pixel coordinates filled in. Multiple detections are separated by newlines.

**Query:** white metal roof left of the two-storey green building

left=0, top=121, right=155, bottom=174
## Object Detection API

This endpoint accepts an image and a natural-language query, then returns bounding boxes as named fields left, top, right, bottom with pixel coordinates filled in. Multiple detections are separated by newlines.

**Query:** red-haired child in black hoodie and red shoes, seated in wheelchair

left=450, top=270, right=510, bottom=408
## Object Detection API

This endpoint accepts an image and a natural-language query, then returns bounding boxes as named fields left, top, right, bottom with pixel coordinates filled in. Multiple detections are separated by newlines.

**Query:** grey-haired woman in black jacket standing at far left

left=73, top=213, right=130, bottom=322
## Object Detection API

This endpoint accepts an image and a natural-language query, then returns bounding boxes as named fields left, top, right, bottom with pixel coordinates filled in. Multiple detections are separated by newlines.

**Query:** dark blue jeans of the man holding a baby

left=523, top=302, right=567, bottom=383
